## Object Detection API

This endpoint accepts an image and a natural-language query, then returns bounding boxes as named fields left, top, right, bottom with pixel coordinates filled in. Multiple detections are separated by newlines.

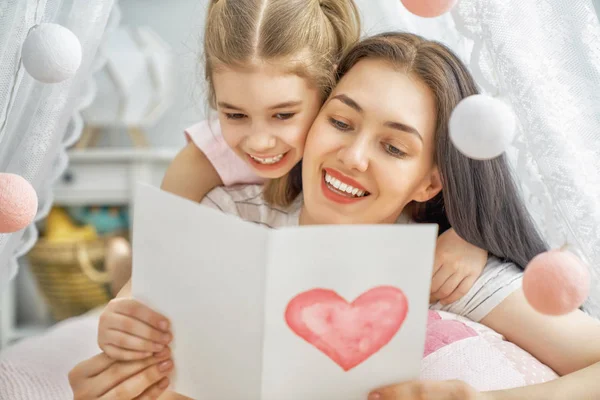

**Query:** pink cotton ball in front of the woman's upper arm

left=523, top=250, right=590, bottom=315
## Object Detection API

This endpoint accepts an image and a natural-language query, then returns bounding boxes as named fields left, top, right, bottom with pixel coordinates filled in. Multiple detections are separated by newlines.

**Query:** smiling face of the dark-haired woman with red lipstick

left=300, top=59, right=441, bottom=224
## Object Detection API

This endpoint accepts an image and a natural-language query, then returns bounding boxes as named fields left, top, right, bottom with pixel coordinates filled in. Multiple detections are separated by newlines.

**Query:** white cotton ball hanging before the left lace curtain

left=21, top=24, right=81, bottom=83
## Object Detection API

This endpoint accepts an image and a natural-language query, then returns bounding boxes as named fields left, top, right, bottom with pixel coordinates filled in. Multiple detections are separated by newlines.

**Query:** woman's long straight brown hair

left=288, top=33, right=547, bottom=268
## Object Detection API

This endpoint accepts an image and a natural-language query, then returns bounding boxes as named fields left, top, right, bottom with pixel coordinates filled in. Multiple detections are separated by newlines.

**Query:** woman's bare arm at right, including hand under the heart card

left=369, top=289, right=600, bottom=400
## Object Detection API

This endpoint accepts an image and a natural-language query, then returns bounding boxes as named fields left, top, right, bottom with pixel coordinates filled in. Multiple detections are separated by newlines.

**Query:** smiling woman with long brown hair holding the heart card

left=68, top=33, right=600, bottom=400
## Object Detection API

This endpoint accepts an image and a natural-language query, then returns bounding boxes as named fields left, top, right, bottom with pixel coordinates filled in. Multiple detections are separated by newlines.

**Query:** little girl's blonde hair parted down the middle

left=204, top=0, right=360, bottom=205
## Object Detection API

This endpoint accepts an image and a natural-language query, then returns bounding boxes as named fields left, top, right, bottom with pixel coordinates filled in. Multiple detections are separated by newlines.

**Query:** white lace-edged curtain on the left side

left=0, top=0, right=118, bottom=292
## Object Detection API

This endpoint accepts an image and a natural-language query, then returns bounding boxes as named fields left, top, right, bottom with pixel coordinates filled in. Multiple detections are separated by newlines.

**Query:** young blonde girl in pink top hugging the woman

left=98, top=0, right=487, bottom=359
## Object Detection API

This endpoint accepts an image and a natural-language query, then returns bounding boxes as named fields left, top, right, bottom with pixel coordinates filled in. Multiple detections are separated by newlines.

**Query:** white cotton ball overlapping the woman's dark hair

left=448, top=94, right=516, bottom=160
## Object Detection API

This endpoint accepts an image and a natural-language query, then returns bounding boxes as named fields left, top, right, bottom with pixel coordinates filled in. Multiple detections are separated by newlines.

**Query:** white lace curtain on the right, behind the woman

left=452, top=0, right=600, bottom=317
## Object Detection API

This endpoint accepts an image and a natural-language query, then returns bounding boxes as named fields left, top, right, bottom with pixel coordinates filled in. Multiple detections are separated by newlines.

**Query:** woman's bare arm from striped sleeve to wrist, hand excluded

left=481, top=289, right=600, bottom=400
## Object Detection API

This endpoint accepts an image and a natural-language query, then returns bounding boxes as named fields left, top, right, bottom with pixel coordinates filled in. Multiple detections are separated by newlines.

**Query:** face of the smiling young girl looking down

left=213, top=63, right=321, bottom=179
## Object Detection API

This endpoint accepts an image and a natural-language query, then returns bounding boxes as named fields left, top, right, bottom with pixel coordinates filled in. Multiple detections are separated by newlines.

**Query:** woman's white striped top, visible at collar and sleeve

left=201, top=185, right=523, bottom=322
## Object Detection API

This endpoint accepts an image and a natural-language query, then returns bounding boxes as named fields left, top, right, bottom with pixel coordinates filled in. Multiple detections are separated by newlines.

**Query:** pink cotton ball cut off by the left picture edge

left=0, top=173, right=37, bottom=233
